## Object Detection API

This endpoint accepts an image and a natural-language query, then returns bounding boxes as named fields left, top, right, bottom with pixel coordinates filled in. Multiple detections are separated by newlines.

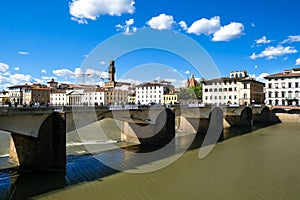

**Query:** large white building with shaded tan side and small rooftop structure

left=202, top=71, right=264, bottom=105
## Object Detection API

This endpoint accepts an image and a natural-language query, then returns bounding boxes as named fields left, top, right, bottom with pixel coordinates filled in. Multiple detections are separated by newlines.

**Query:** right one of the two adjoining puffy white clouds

left=212, top=22, right=244, bottom=41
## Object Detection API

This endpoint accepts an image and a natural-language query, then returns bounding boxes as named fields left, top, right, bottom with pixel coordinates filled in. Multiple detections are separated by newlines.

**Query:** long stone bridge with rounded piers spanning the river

left=0, top=106, right=278, bottom=170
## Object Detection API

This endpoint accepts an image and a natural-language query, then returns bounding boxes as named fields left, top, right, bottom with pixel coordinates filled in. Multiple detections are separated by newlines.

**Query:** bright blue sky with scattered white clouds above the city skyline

left=0, top=0, right=300, bottom=90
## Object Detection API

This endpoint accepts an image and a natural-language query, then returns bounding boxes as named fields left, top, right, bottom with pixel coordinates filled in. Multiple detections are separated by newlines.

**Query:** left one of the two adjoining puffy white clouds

left=187, top=16, right=221, bottom=35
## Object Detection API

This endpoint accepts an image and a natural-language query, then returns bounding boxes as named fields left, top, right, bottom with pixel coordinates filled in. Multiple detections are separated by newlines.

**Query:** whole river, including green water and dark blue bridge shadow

left=0, top=119, right=300, bottom=200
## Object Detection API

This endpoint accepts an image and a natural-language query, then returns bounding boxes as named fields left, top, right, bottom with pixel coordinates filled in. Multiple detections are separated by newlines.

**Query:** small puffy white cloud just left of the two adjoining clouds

left=146, top=14, right=176, bottom=30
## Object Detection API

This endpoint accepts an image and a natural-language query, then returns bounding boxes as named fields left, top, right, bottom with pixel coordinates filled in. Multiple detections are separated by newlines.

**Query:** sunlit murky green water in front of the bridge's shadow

left=0, top=123, right=300, bottom=200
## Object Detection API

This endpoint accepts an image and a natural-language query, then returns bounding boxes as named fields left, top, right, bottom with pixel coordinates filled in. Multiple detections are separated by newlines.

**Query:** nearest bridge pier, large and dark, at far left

left=10, top=113, right=66, bottom=171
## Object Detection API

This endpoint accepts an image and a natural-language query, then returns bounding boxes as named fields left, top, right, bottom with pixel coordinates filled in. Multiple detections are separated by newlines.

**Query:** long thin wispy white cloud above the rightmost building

left=249, top=45, right=298, bottom=60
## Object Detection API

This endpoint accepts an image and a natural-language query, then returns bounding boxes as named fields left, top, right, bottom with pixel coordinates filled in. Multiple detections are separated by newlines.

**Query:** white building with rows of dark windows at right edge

left=265, top=68, right=300, bottom=106
